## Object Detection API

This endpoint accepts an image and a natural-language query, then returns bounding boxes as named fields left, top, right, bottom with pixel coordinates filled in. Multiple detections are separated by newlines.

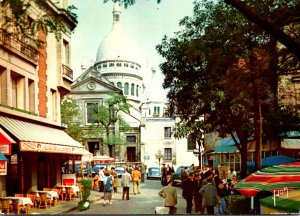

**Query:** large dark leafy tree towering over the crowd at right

left=157, top=1, right=300, bottom=177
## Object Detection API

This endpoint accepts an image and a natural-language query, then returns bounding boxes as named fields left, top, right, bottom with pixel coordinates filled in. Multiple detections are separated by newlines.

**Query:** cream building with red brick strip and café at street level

left=0, top=0, right=84, bottom=197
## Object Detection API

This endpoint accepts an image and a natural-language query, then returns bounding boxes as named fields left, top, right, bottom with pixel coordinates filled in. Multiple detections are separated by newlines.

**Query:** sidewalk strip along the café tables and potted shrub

left=30, top=190, right=103, bottom=214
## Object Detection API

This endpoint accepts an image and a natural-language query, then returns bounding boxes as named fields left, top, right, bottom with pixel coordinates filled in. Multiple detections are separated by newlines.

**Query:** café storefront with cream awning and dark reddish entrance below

left=0, top=116, right=84, bottom=196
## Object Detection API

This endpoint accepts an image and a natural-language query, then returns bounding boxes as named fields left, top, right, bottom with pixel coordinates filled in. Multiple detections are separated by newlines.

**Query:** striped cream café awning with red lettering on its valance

left=0, top=116, right=84, bottom=155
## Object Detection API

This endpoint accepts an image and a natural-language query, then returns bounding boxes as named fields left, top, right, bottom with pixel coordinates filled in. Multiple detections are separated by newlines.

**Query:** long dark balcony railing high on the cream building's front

left=0, top=29, right=38, bottom=62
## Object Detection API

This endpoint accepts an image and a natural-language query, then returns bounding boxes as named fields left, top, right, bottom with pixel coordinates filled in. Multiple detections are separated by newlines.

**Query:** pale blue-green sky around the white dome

left=70, top=0, right=193, bottom=79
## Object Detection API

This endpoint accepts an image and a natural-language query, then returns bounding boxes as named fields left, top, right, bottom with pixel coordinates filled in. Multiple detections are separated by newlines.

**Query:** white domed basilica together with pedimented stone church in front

left=68, top=2, right=197, bottom=166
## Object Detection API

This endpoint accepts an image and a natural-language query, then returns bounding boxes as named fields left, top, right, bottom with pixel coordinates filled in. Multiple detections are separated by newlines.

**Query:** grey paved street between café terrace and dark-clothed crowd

left=70, top=180, right=189, bottom=214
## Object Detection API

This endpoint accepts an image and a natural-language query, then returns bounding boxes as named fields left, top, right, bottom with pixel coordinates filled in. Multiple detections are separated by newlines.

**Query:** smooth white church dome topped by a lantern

left=95, top=2, right=140, bottom=64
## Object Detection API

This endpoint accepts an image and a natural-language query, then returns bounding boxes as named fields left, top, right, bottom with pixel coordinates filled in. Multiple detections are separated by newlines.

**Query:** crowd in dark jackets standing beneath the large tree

left=158, top=164, right=237, bottom=214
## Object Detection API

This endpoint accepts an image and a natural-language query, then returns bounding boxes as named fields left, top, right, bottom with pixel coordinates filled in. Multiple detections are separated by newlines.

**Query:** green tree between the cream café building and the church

left=61, top=99, right=84, bottom=142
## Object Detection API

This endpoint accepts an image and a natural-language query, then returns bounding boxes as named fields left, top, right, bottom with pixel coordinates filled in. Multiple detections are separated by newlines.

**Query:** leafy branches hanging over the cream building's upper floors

left=0, top=0, right=77, bottom=47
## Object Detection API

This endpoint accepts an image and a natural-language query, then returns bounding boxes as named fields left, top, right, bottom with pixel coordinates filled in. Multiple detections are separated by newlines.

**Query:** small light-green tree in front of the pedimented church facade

left=90, top=93, right=131, bottom=157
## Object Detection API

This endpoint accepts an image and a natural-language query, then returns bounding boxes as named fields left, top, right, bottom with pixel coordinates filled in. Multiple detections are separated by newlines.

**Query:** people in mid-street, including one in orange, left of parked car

left=91, top=166, right=142, bottom=206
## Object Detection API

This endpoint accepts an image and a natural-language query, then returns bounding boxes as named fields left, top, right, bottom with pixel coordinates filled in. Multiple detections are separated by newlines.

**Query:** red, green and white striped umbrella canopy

left=236, top=162, right=300, bottom=196
